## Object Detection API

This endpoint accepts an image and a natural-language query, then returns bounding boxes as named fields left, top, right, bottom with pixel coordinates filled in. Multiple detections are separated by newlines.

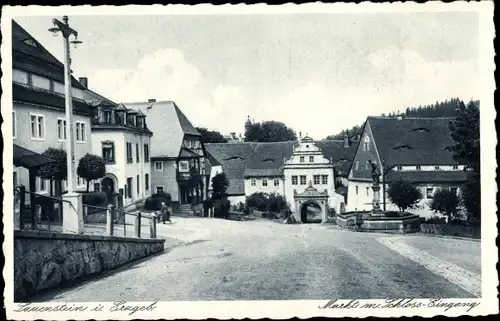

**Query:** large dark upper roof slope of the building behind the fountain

left=368, top=117, right=456, bottom=166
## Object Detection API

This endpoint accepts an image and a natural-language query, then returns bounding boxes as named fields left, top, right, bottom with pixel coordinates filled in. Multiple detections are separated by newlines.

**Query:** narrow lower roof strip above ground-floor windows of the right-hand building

left=386, top=170, right=469, bottom=183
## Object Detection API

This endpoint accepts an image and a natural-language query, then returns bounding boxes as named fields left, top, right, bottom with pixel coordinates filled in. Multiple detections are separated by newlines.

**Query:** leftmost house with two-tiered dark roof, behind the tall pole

left=12, top=21, right=92, bottom=194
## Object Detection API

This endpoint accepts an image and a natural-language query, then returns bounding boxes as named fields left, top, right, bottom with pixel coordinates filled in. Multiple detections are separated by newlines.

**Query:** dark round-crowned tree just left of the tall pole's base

left=37, top=147, right=68, bottom=195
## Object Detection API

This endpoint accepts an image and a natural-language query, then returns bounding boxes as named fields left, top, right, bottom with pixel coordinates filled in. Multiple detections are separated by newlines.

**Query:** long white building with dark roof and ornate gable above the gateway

left=206, top=132, right=355, bottom=211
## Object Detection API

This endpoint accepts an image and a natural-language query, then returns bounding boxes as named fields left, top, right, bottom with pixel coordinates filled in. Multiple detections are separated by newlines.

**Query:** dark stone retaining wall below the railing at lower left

left=14, top=231, right=165, bottom=302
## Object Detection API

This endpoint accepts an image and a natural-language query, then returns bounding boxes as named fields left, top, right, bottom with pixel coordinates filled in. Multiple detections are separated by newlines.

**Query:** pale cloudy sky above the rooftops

left=15, top=12, right=480, bottom=139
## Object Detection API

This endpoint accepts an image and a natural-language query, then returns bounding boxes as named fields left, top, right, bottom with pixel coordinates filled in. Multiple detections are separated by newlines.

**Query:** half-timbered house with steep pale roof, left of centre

left=124, top=99, right=209, bottom=208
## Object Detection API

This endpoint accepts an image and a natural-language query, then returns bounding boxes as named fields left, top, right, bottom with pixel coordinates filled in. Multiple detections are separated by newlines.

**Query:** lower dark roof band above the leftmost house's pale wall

left=12, top=83, right=92, bottom=115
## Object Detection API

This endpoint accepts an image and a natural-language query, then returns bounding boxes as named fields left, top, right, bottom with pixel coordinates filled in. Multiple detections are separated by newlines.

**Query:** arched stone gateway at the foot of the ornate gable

left=293, top=182, right=328, bottom=223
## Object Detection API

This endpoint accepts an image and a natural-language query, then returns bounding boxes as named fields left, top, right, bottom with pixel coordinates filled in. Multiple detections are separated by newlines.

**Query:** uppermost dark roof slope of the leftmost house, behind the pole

left=12, top=20, right=85, bottom=89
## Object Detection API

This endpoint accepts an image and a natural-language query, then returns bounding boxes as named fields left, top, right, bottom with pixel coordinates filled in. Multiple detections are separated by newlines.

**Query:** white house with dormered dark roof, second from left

left=80, top=78, right=153, bottom=207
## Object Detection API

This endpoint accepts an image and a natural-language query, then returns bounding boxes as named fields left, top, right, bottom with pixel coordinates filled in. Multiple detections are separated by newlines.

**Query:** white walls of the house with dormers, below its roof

left=92, top=128, right=152, bottom=206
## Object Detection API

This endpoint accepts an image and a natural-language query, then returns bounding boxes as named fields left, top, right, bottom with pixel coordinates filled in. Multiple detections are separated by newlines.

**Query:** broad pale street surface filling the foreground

left=36, top=217, right=481, bottom=302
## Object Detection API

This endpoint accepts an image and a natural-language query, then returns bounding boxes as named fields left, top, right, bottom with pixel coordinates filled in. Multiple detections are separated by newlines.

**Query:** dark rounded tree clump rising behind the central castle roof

left=245, top=120, right=297, bottom=142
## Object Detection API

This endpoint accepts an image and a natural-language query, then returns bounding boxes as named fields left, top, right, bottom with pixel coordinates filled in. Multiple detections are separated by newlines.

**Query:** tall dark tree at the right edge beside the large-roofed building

left=449, top=101, right=481, bottom=221
